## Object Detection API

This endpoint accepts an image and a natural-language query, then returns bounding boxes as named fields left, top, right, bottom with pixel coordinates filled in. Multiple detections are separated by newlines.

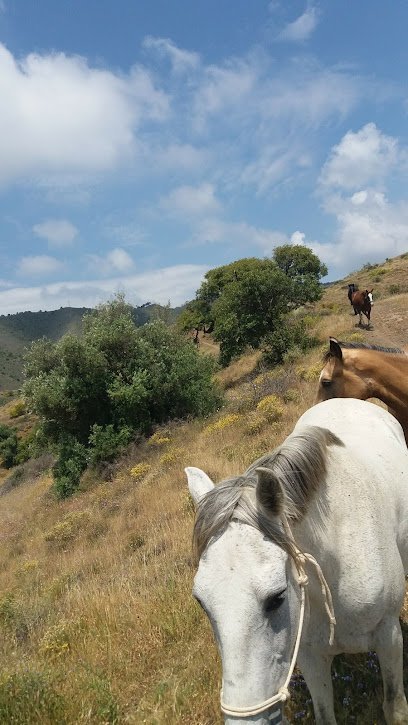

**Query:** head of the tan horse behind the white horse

left=316, top=337, right=369, bottom=403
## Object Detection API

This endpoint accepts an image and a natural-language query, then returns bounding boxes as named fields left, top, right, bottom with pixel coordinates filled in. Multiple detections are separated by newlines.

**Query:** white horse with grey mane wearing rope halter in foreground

left=186, top=399, right=408, bottom=725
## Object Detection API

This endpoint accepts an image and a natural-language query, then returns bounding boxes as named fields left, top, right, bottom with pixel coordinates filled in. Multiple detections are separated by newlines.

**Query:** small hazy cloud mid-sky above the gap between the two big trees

left=160, top=184, right=221, bottom=218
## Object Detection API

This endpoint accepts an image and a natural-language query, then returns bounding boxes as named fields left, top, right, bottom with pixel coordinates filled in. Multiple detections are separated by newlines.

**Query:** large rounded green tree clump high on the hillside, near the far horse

left=179, top=245, right=327, bottom=365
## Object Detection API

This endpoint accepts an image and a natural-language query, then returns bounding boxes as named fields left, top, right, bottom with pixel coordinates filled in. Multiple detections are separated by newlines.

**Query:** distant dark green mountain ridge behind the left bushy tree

left=0, top=302, right=183, bottom=391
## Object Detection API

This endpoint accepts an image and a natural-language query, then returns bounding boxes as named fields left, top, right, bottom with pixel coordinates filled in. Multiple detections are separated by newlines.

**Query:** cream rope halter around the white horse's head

left=220, top=515, right=336, bottom=717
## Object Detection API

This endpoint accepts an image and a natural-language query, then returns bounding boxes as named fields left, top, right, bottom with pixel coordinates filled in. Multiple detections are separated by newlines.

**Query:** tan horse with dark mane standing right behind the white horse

left=316, top=337, right=408, bottom=445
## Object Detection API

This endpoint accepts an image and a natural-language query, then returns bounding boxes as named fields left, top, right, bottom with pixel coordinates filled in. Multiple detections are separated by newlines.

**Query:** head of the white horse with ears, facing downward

left=186, top=468, right=300, bottom=725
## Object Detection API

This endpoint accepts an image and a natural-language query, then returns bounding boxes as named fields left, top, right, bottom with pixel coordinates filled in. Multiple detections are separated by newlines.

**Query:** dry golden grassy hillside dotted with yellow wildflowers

left=0, top=253, right=408, bottom=725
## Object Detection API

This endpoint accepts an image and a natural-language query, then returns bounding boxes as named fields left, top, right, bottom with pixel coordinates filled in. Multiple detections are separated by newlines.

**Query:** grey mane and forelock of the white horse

left=193, top=426, right=343, bottom=558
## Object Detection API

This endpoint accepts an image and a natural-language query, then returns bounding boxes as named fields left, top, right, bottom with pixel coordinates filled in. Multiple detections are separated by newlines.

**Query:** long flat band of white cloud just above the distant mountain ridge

left=0, top=264, right=208, bottom=314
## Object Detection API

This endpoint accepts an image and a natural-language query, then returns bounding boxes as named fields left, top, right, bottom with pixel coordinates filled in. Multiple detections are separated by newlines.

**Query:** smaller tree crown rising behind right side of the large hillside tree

left=273, top=244, right=327, bottom=306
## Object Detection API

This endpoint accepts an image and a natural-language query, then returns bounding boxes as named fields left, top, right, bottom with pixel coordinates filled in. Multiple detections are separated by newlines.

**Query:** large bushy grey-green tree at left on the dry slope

left=24, top=296, right=220, bottom=496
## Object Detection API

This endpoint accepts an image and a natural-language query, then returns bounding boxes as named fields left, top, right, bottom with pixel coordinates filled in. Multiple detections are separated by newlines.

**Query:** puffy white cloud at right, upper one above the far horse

left=320, top=123, right=400, bottom=190
